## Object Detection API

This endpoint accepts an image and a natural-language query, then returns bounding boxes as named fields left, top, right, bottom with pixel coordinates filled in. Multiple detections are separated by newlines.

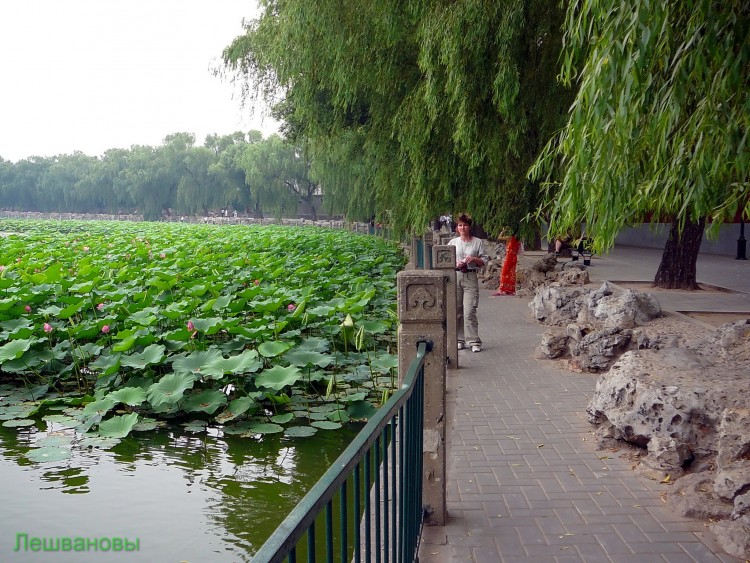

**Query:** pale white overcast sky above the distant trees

left=0, top=0, right=277, bottom=161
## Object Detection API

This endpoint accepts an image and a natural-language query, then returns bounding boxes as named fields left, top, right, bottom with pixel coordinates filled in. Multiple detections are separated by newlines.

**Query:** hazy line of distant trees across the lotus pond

left=0, top=131, right=320, bottom=220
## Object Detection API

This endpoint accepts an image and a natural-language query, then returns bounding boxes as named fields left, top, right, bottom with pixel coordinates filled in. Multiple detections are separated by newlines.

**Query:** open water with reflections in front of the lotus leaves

left=0, top=425, right=355, bottom=563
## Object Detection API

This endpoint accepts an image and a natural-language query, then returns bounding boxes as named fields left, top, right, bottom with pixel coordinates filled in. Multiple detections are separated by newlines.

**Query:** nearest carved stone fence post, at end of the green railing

left=397, top=270, right=447, bottom=526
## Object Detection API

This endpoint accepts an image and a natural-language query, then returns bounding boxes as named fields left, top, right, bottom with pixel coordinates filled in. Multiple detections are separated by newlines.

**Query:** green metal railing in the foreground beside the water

left=253, top=341, right=432, bottom=563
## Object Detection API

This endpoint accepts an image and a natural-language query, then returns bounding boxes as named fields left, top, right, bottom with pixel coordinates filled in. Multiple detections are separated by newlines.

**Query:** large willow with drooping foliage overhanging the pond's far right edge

left=224, top=0, right=572, bottom=239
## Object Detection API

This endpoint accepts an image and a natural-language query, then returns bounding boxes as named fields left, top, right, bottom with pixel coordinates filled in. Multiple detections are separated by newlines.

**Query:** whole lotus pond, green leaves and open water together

left=0, top=221, right=404, bottom=561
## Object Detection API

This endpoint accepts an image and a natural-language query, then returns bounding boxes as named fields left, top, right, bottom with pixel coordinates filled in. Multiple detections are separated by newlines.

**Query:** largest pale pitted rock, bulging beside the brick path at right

left=586, top=349, right=750, bottom=470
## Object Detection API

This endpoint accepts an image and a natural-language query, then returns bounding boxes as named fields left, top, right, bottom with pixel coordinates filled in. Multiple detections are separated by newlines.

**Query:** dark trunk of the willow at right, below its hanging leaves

left=654, top=218, right=706, bottom=290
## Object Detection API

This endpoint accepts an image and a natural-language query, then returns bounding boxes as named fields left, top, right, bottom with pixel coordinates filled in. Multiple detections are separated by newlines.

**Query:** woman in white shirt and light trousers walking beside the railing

left=448, top=213, right=489, bottom=352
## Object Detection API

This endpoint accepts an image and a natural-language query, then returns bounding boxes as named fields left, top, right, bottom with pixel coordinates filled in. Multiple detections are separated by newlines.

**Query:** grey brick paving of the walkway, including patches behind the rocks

left=420, top=249, right=750, bottom=563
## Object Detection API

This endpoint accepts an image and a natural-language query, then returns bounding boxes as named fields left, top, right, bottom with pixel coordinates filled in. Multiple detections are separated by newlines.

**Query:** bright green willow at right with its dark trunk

left=532, top=0, right=750, bottom=289
